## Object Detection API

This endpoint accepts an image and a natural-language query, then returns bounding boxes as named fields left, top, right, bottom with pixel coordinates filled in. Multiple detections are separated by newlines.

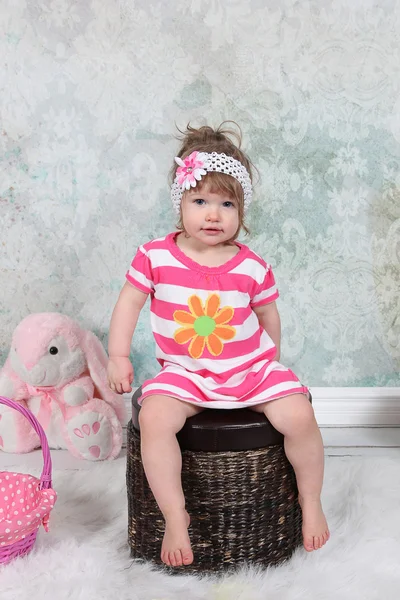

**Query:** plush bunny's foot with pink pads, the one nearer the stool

left=66, top=411, right=112, bottom=460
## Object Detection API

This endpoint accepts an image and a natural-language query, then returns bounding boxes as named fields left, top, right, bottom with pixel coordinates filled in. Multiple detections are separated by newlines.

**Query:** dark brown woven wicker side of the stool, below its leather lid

left=127, top=422, right=302, bottom=574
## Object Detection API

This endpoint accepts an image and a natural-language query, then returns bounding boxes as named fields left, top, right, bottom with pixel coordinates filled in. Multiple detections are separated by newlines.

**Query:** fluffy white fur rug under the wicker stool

left=0, top=451, right=400, bottom=600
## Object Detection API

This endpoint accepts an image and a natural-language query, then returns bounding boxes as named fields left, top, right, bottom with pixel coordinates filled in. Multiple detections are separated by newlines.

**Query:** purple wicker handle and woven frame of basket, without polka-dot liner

left=0, top=396, right=56, bottom=564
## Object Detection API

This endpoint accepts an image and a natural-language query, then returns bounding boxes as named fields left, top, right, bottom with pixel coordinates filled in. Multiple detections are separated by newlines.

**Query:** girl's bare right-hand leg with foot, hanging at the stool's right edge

left=251, top=394, right=329, bottom=552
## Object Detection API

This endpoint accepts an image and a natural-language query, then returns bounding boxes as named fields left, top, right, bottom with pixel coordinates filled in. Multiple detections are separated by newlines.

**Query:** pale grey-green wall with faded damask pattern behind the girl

left=0, top=0, right=400, bottom=386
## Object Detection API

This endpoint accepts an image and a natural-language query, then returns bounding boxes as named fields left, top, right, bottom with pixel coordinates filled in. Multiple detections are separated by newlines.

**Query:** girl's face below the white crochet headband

left=181, top=184, right=239, bottom=247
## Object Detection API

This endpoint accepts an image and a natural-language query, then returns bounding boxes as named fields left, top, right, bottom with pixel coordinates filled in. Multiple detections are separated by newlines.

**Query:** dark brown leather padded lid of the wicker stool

left=132, top=388, right=283, bottom=452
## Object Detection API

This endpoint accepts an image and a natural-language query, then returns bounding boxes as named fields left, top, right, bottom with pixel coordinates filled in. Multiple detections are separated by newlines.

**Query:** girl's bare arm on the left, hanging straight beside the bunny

left=107, top=282, right=148, bottom=394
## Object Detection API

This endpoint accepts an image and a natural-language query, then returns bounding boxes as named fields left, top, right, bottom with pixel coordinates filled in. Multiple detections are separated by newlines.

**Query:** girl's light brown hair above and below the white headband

left=170, top=121, right=254, bottom=241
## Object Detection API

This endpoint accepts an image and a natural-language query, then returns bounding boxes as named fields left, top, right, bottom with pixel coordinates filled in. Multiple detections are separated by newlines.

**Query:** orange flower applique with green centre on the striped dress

left=174, top=293, right=236, bottom=358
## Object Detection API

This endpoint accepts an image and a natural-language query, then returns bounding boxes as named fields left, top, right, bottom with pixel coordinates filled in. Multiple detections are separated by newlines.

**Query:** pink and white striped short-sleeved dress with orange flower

left=126, top=232, right=308, bottom=408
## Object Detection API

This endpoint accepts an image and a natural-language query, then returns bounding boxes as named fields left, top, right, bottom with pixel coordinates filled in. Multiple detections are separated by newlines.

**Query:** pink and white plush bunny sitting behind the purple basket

left=0, top=313, right=125, bottom=460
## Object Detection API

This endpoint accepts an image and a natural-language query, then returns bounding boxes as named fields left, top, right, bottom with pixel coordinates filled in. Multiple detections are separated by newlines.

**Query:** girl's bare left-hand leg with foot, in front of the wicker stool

left=139, top=396, right=202, bottom=567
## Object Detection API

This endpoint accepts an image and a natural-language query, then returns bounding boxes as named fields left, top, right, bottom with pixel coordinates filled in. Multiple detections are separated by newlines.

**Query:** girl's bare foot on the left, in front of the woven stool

left=161, top=510, right=193, bottom=567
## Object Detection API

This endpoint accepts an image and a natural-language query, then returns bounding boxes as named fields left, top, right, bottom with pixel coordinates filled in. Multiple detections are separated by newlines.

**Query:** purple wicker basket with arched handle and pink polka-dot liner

left=0, top=396, right=57, bottom=564
